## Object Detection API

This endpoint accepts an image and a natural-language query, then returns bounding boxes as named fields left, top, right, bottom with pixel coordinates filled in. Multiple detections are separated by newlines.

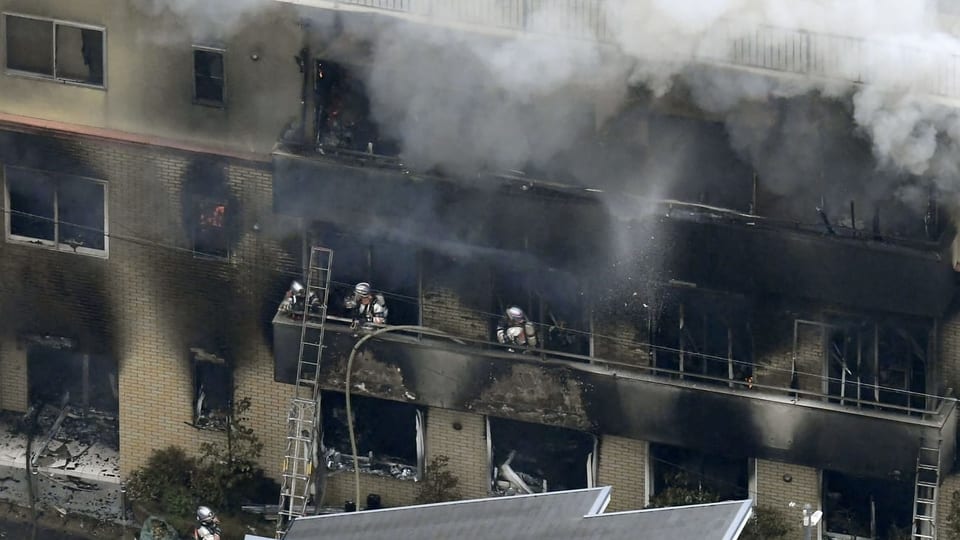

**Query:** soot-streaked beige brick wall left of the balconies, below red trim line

left=0, top=125, right=299, bottom=474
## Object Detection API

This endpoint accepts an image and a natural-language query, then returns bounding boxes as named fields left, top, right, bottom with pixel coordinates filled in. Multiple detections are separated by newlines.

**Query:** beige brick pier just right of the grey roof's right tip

left=754, top=459, right=823, bottom=538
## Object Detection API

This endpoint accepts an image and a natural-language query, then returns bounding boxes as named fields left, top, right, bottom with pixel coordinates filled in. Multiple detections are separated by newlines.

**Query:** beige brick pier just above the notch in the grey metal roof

left=597, top=435, right=649, bottom=512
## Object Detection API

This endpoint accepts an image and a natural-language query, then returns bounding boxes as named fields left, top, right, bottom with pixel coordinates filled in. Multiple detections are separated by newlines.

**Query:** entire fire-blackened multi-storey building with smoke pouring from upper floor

left=0, top=0, right=960, bottom=538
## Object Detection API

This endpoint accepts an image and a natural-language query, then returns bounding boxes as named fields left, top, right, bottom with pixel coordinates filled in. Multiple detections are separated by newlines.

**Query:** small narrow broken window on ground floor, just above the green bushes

left=190, top=349, right=233, bottom=430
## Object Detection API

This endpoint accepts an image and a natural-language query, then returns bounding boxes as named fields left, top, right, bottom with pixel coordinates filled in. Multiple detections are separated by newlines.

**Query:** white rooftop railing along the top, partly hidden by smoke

left=281, top=0, right=960, bottom=102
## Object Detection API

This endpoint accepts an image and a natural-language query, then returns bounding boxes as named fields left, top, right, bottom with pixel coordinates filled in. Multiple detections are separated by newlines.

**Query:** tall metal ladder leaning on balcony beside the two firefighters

left=276, top=247, right=333, bottom=540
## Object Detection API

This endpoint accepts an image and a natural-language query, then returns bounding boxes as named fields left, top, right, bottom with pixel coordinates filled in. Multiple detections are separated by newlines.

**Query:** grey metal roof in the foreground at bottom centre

left=284, top=487, right=750, bottom=540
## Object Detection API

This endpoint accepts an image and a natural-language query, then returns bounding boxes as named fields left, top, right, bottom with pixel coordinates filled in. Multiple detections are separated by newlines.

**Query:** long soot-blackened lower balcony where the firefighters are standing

left=273, top=313, right=956, bottom=478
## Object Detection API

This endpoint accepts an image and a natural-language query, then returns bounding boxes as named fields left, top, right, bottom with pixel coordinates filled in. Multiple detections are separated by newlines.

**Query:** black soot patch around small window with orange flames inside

left=182, top=159, right=239, bottom=258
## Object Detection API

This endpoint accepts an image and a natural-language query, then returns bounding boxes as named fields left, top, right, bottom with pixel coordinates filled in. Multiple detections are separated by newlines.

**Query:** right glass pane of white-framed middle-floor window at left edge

left=57, top=177, right=104, bottom=249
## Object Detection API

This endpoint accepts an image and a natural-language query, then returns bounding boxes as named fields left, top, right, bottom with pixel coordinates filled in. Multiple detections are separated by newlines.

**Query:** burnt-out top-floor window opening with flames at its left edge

left=313, top=60, right=399, bottom=156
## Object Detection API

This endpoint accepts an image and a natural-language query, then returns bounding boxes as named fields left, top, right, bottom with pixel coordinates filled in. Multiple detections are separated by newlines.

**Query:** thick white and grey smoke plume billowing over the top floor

left=136, top=0, right=960, bottom=221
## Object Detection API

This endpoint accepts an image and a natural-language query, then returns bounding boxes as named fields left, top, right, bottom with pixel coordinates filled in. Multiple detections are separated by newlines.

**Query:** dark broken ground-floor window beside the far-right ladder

left=823, top=471, right=913, bottom=540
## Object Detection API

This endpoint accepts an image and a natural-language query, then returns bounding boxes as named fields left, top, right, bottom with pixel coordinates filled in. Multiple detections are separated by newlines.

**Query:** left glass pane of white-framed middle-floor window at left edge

left=6, top=168, right=55, bottom=241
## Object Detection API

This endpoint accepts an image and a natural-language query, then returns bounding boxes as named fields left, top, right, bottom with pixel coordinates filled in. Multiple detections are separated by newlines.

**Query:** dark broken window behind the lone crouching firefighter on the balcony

left=491, top=268, right=590, bottom=356
